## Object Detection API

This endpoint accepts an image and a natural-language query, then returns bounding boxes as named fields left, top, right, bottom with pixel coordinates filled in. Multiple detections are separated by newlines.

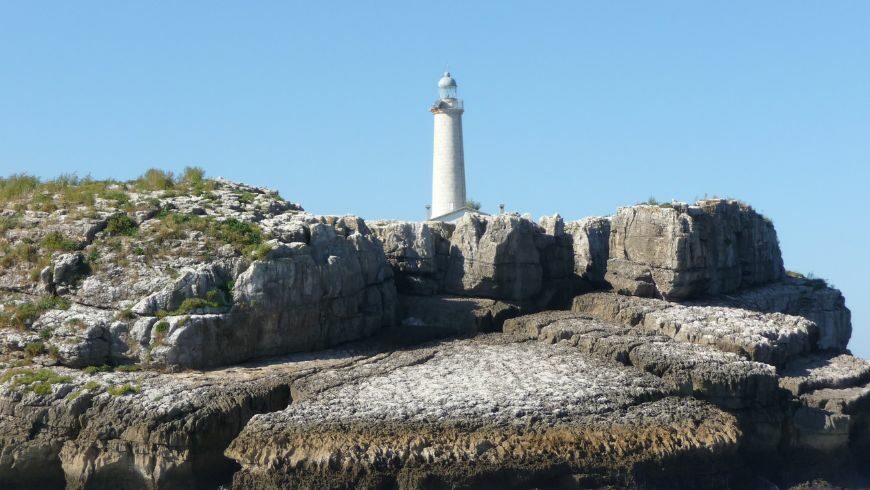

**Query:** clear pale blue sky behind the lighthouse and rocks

left=0, top=1, right=870, bottom=357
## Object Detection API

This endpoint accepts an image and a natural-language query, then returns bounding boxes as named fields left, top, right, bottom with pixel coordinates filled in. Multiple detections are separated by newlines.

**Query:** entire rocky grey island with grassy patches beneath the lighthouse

left=0, top=171, right=870, bottom=489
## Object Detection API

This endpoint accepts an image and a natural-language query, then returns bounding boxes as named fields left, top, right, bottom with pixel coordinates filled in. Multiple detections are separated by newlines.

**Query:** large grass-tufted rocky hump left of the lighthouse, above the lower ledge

left=0, top=181, right=396, bottom=369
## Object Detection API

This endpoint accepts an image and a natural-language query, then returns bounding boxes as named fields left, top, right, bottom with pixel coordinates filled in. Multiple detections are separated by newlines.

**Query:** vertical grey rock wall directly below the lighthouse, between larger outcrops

left=371, top=214, right=610, bottom=303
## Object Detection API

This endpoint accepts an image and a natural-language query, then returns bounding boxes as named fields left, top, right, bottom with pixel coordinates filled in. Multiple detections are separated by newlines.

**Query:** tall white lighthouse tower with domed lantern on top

left=429, top=72, right=470, bottom=221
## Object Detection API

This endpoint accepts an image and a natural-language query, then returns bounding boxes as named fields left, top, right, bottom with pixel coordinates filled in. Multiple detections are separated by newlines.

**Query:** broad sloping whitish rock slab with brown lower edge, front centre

left=227, top=336, right=740, bottom=488
